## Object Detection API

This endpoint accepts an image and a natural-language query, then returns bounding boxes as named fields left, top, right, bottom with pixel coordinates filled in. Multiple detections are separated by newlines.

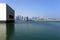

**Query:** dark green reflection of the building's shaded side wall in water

left=6, top=23, right=14, bottom=40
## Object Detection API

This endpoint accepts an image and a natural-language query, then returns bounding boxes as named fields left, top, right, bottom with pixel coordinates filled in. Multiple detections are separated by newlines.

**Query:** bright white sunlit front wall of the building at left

left=0, top=3, right=6, bottom=21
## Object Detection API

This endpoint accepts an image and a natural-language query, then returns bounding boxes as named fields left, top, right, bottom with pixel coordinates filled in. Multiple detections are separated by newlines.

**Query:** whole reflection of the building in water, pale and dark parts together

left=0, top=23, right=14, bottom=40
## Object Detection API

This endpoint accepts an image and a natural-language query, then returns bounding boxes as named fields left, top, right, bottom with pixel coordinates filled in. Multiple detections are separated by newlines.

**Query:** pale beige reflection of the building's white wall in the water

left=0, top=23, right=6, bottom=40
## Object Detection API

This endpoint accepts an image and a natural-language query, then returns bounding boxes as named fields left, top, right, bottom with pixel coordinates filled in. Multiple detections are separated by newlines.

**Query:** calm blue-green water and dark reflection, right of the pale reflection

left=0, top=22, right=60, bottom=40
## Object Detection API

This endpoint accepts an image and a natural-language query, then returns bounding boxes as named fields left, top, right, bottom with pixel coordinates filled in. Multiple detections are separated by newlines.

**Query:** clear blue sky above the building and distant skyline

left=0, top=0, right=60, bottom=18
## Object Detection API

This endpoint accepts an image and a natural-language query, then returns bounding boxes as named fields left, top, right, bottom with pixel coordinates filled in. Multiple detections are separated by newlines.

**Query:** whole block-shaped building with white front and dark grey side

left=0, top=3, right=15, bottom=22
